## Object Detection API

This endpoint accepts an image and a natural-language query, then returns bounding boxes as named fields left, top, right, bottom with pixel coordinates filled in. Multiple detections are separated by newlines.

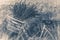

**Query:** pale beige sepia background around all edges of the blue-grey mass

left=0, top=0, right=60, bottom=40
